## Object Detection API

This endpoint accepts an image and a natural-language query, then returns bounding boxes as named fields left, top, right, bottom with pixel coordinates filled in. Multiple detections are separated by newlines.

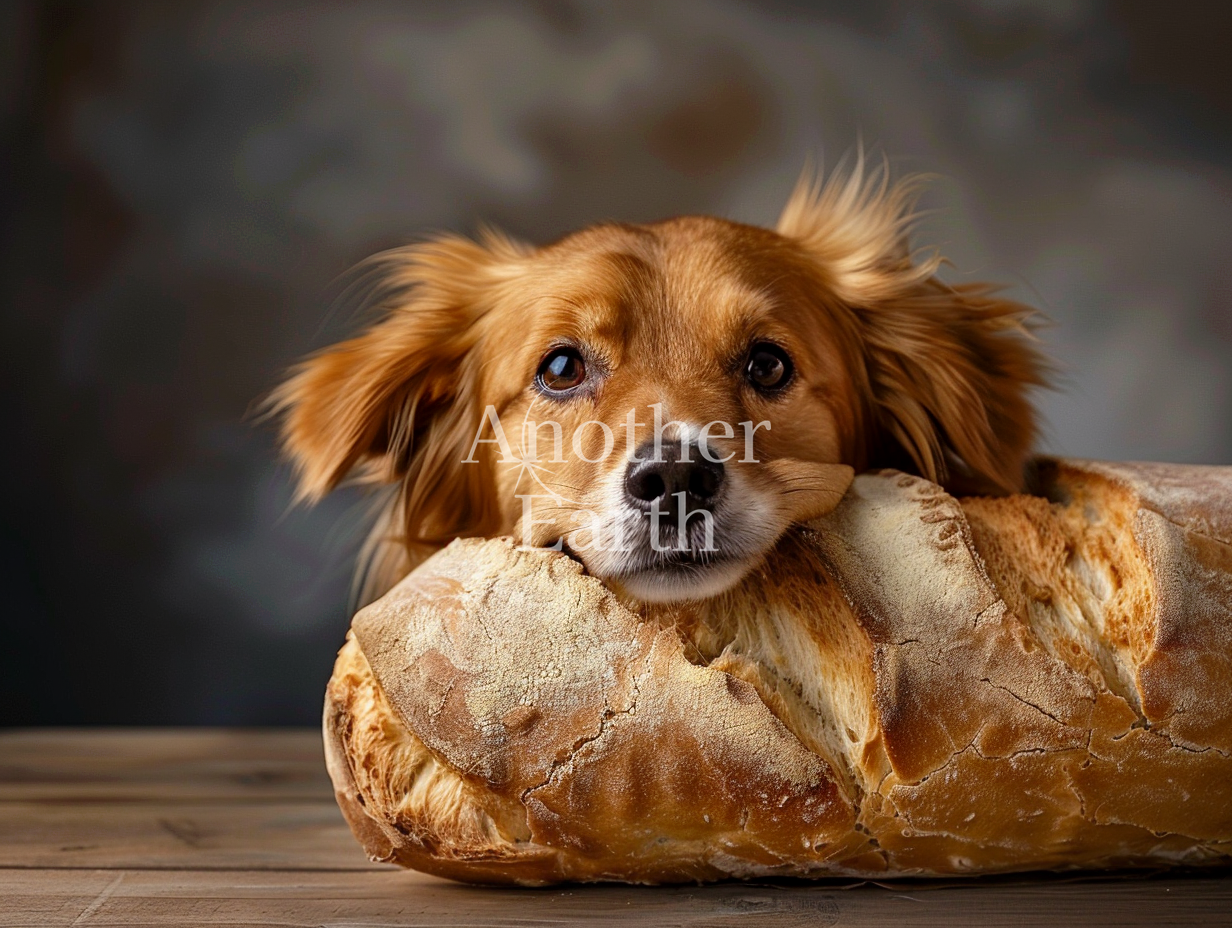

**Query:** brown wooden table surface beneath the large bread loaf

left=0, top=730, right=1232, bottom=928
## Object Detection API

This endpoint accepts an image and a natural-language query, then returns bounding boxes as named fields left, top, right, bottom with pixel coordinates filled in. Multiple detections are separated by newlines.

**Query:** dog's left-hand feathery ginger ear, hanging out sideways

left=267, top=226, right=525, bottom=534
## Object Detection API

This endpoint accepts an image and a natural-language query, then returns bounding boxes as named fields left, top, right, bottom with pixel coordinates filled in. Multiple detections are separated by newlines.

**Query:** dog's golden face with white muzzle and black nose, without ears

left=473, top=218, right=859, bottom=600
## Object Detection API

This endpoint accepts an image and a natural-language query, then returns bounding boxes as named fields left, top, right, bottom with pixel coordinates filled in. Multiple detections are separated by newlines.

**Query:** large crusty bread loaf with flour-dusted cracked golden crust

left=325, top=460, right=1232, bottom=884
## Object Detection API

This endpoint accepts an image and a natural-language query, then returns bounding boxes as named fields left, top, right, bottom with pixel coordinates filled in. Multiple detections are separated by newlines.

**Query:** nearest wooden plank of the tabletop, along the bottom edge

left=0, top=870, right=1232, bottom=928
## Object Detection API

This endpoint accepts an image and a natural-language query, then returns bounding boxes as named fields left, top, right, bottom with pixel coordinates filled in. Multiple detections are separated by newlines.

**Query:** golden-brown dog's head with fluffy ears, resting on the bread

left=275, top=165, right=1042, bottom=600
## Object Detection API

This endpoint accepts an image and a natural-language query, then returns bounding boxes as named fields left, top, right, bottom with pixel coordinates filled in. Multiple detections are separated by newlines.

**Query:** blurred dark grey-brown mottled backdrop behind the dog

left=0, top=0, right=1232, bottom=723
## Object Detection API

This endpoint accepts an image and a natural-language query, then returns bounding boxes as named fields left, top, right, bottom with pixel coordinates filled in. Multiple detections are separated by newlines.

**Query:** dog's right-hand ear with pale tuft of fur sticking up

left=777, top=157, right=1047, bottom=494
